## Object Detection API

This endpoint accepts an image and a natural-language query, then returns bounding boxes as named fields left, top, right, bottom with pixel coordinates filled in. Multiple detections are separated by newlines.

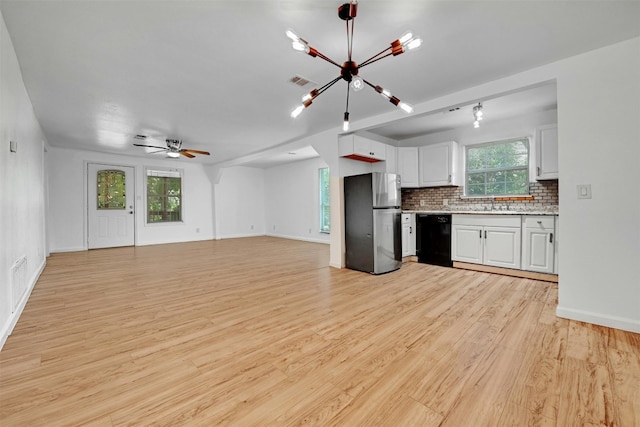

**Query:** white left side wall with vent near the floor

left=0, top=13, right=46, bottom=348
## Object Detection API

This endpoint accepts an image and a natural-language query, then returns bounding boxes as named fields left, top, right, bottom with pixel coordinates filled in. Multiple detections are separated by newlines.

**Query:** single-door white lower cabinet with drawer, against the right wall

left=522, top=216, right=555, bottom=274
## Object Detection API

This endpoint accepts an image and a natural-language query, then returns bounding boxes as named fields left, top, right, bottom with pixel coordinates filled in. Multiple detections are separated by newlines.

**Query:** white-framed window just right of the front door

left=147, top=169, right=182, bottom=223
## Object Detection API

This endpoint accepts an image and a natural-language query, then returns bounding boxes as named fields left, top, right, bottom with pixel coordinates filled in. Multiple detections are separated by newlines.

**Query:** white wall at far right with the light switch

left=558, top=38, right=640, bottom=332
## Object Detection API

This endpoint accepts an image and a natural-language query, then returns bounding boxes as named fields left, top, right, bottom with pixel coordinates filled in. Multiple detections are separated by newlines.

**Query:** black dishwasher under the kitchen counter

left=416, top=214, right=453, bottom=267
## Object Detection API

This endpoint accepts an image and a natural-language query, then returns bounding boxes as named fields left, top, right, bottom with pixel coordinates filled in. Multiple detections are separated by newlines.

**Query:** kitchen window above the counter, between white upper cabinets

left=465, top=138, right=529, bottom=196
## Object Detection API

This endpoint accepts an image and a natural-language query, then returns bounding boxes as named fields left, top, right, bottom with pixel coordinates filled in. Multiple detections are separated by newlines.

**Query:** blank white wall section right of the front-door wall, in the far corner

left=214, top=166, right=266, bottom=239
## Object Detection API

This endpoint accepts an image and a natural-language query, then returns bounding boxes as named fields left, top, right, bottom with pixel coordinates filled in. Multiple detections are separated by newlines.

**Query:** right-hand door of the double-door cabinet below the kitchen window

left=483, top=227, right=521, bottom=269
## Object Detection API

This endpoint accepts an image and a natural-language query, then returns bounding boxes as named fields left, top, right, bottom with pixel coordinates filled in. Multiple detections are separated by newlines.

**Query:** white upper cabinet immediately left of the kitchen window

left=418, top=141, right=459, bottom=187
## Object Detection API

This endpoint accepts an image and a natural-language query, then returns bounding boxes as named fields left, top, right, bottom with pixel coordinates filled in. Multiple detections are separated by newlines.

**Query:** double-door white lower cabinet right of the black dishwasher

left=451, top=215, right=522, bottom=269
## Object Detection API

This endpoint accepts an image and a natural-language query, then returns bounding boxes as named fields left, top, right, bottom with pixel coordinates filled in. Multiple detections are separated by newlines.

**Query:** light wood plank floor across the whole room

left=0, top=237, right=640, bottom=427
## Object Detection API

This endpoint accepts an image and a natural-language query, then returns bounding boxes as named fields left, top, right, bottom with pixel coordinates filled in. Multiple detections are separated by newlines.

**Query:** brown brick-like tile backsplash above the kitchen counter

left=402, top=179, right=558, bottom=211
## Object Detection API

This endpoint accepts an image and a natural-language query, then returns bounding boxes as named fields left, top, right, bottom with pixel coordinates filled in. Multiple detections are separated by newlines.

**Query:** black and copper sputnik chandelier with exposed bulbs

left=286, top=0, right=422, bottom=132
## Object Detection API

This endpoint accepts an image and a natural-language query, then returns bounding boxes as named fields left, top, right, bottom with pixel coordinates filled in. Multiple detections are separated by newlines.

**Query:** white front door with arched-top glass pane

left=87, top=163, right=135, bottom=249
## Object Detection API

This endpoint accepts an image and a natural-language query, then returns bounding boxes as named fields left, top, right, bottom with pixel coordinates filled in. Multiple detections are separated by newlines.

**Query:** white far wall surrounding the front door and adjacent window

left=48, top=147, right=214, bottom=252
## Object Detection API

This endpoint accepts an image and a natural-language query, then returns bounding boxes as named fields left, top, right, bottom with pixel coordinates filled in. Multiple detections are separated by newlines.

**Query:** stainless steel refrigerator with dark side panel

left=344, top=172, right=402, bottom=274
